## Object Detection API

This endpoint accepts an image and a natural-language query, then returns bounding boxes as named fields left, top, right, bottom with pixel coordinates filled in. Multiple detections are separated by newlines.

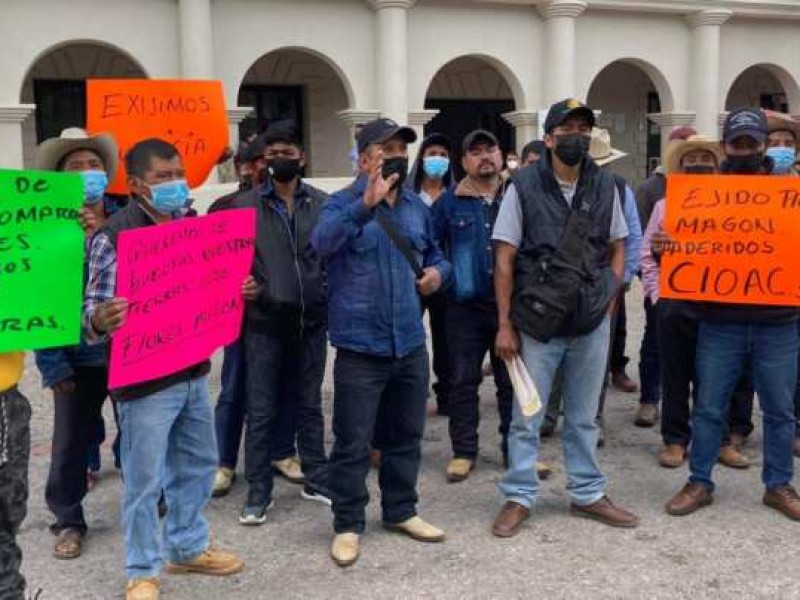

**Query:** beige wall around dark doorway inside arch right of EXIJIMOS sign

left=243, top=50, right=350, bottom=177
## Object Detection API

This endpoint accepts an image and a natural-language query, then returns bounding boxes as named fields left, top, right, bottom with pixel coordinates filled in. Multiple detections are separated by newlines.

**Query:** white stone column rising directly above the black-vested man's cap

left=538, top=0, right=588, bottom=106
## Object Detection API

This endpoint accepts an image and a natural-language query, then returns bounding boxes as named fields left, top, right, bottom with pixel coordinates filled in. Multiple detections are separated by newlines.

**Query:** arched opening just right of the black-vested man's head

left=586, top=59, right=674, bottom=185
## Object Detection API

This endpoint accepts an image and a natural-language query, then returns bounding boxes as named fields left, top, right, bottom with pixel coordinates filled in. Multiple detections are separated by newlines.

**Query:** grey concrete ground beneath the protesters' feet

left=14, top=291, right=800, bottom=600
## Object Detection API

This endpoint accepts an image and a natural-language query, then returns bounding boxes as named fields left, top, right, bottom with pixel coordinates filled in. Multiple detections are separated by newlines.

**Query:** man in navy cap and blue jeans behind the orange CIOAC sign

left=666, top=108, right=800, bottom=521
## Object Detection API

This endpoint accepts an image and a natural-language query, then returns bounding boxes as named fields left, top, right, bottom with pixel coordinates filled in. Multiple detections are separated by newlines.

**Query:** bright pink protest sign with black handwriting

left=109, top=209, right=256, bottom=389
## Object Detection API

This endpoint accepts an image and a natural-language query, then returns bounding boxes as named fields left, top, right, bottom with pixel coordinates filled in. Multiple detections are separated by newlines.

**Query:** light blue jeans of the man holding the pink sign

left=119, top=376, right=217, bottom=579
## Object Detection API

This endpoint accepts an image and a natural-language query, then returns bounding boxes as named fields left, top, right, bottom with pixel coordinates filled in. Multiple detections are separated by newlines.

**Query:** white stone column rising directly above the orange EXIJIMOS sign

left=178, top=0, right=214, bottom=79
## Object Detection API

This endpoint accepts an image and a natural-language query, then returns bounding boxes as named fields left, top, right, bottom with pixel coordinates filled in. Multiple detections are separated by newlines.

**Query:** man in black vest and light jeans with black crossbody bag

left=492, top=100, right=638, bottom=537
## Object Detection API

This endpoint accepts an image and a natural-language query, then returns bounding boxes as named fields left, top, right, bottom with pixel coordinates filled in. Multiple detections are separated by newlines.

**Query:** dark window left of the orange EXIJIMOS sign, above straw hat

left=33, top=79, right=86, bottom=143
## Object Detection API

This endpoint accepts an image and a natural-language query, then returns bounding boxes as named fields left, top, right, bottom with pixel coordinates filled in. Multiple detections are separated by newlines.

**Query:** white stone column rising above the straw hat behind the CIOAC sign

left=687, top=8, right=733, bottom=137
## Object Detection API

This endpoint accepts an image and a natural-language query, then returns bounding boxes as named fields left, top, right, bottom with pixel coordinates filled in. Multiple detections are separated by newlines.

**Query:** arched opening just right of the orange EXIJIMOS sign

left=238, top=48, right=352, bottom=177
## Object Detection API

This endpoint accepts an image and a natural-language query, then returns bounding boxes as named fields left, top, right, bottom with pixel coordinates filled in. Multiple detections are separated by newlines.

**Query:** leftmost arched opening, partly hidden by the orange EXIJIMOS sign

left=20, top=41, right=147, bottom=166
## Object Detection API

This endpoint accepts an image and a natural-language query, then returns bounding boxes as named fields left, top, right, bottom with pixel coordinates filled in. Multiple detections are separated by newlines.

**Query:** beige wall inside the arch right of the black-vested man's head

left=587, top=62, right=656, bottom=184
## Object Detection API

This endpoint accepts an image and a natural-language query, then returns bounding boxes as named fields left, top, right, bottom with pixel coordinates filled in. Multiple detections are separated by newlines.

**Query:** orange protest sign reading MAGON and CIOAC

left=661, top=175, right=800, bottom=306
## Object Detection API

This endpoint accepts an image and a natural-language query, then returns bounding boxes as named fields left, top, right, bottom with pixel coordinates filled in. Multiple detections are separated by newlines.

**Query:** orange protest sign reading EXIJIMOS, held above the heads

left=86, top=79, right=228, bottom=194
